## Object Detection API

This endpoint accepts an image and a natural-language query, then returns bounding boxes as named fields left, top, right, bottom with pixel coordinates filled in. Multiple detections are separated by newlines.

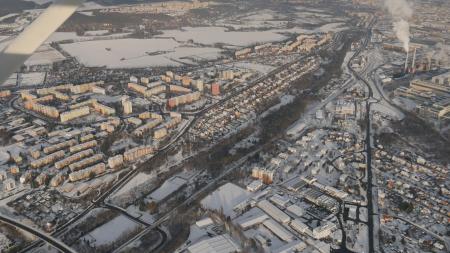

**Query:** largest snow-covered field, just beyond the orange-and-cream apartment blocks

left=61, top=38, right=221, bottom=68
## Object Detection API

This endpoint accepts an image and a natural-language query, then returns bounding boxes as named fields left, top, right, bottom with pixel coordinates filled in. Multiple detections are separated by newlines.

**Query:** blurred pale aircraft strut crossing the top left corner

left=0, top=0, right=84, bottom=84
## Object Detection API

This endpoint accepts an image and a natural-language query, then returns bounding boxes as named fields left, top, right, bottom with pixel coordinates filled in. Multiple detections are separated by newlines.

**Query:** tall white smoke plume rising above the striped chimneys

left=384, top=0, right=413, bottom=52
